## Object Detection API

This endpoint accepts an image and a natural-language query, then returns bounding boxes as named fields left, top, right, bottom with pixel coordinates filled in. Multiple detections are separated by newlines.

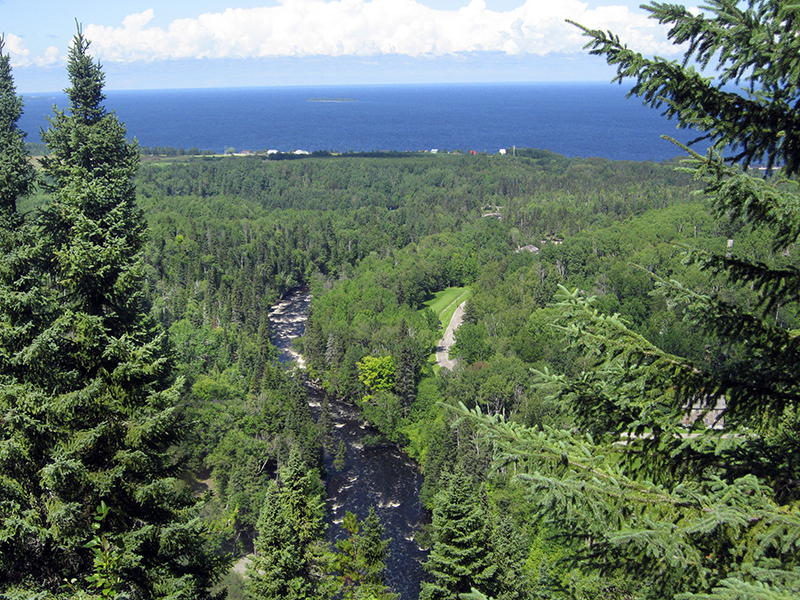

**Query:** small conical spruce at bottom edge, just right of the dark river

left=420, top=467, right=497, bottom=600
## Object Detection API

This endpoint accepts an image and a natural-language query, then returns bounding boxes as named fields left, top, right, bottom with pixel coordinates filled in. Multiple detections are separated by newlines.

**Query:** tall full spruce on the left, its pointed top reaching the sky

left=0, top=29, right=222, bottom=598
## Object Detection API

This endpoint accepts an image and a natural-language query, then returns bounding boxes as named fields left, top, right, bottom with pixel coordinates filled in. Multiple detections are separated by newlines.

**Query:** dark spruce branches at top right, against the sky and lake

left=574, top=0, right=800, bottom=175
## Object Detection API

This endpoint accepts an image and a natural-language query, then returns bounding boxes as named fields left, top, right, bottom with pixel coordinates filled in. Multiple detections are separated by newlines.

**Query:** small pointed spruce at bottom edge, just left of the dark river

left=248, top=448, right=325, bottom=600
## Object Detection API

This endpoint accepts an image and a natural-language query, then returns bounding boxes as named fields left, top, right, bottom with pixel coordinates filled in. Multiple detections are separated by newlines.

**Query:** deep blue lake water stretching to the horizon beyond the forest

left=20, top=83, right=708, bottom=161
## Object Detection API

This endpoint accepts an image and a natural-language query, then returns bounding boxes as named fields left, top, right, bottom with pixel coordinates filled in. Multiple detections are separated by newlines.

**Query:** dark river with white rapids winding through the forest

left=270, top=288, right=428, bottom=600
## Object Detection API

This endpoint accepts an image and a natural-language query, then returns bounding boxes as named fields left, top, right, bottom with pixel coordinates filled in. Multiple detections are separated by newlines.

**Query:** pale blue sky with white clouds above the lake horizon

left=0, top=0, right=692, bottom=94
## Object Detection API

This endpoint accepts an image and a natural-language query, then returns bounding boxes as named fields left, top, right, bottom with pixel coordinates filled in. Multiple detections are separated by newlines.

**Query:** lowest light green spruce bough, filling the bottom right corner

left=453, top=406, right=800, bottom=598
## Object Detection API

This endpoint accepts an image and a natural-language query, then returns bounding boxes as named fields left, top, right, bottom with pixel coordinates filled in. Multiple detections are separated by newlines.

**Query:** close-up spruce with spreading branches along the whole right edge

left=460, top=0, right=800, bottom=600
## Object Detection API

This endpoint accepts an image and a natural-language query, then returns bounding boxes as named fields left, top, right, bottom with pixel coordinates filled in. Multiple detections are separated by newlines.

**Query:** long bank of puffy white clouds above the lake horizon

left=78, top=0, right=674, bottom=62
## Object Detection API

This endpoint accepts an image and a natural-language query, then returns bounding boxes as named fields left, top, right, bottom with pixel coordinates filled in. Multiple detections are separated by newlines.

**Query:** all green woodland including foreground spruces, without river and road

left=0, top=1, right=800, bottom=600
